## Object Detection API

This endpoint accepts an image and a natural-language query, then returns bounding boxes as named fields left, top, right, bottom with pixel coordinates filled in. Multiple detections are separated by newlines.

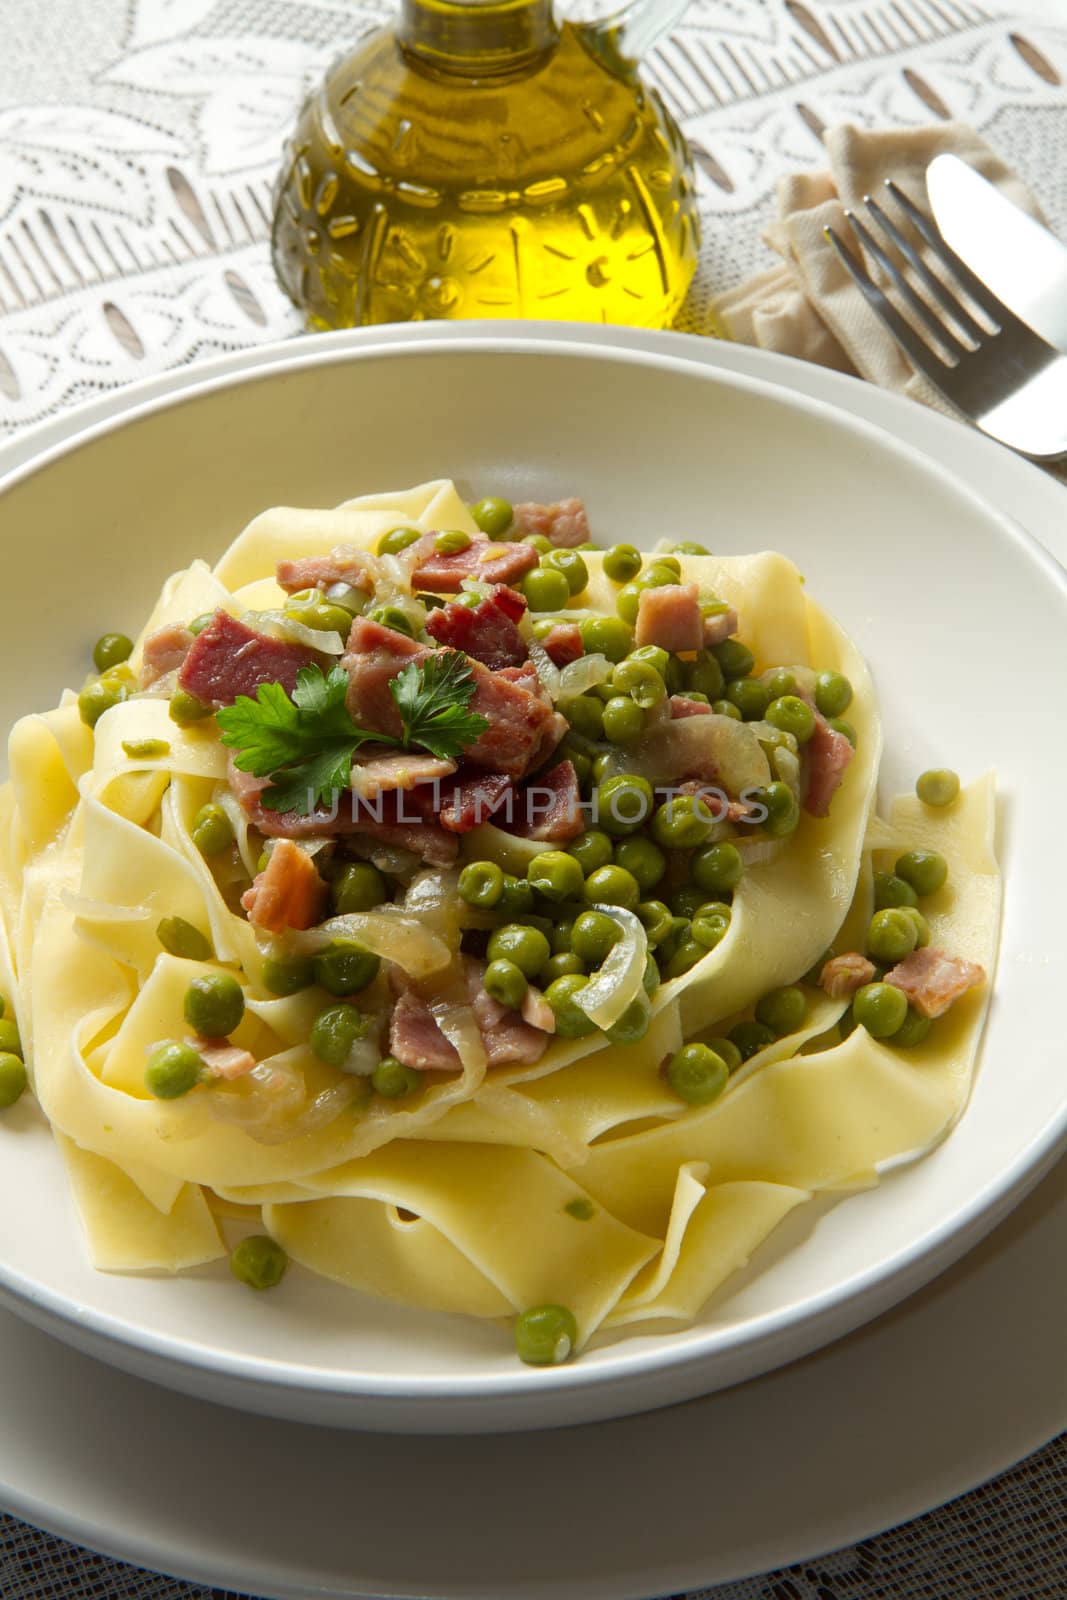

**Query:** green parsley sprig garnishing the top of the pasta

left=218, top=650, right=490, bottom=816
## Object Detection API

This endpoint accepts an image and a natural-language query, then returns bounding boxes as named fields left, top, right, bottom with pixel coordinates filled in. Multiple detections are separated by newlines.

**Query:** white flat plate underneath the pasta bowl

left=0, top=330, right=1067, bottom=1600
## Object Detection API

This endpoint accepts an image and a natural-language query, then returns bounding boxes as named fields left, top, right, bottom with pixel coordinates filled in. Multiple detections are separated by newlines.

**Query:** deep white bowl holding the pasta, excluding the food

left=0, top=330, right=1067, bottom=1432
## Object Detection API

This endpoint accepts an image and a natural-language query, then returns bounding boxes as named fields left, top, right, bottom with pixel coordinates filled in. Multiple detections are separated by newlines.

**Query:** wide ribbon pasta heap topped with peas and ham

left=0, top=482, right=1000, bottom=1354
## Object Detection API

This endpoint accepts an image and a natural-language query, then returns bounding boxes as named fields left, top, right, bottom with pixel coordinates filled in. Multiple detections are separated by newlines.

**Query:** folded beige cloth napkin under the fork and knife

left=715, top=122, right=1045, bottom=414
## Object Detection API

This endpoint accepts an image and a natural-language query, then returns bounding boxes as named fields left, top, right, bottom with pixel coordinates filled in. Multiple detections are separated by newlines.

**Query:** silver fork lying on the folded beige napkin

left=824, top=178, right=1067, bottom=461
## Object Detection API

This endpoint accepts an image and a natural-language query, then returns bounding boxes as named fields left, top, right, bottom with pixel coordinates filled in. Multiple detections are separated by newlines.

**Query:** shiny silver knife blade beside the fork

left=926, top=155, right=1067, bottom=354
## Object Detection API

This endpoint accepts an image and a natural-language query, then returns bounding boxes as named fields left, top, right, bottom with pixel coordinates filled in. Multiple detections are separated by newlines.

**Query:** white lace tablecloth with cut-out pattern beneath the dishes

left=0, top=0, right=1067, bottom=1600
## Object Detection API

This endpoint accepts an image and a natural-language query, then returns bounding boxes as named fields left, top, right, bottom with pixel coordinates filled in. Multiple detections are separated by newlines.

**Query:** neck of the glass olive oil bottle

left=397, top=0, right=560, bottom=78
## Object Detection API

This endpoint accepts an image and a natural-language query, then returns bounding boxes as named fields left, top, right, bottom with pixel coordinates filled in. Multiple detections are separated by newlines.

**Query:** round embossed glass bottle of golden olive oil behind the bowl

left=274, top=0, right=699, bottom=328
